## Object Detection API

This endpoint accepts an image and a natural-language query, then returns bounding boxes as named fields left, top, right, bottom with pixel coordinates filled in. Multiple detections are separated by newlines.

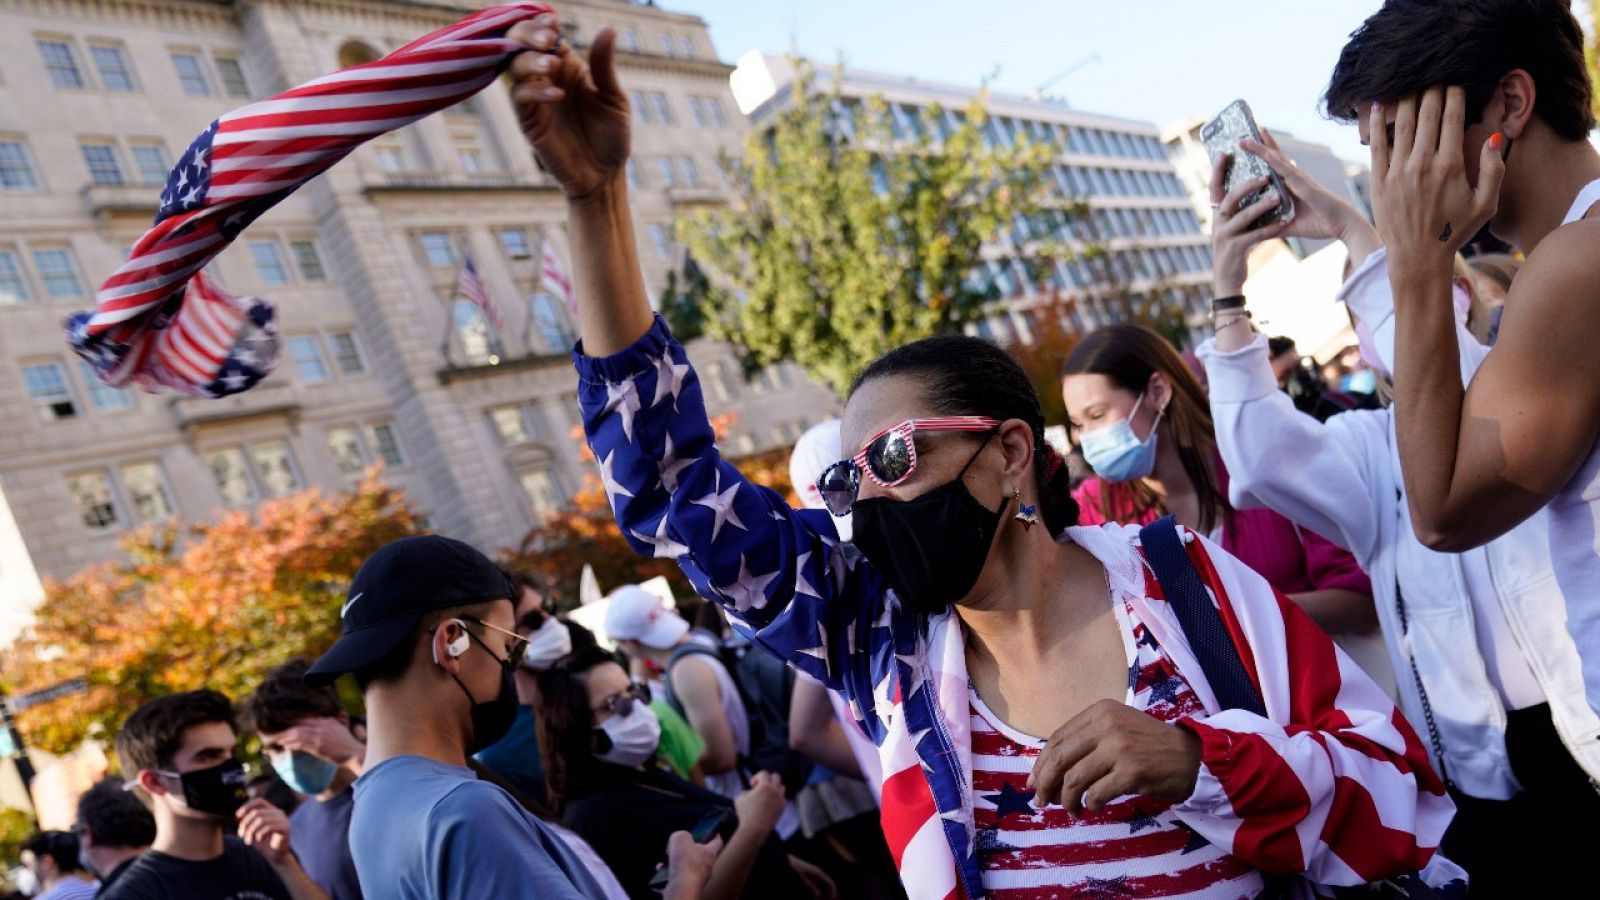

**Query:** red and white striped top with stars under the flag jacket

left=970, top=592, right=1262, bottom=900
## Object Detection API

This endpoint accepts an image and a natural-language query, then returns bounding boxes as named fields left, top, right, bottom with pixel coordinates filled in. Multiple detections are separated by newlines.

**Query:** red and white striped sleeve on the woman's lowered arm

left=1154, top=536, right=1454, bottom=886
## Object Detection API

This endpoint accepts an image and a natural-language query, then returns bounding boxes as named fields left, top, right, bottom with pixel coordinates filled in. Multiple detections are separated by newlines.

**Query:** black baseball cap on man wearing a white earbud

left=306, top=535, right=517, bottom=687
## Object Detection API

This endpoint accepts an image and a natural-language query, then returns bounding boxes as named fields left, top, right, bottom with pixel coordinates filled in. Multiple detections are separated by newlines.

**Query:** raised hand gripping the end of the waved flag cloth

left=506, top=13, right=629, bottom=200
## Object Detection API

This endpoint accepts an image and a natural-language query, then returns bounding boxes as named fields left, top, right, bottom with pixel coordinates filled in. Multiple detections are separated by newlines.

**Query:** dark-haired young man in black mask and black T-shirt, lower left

left=104, top=690, right=328, bottom=900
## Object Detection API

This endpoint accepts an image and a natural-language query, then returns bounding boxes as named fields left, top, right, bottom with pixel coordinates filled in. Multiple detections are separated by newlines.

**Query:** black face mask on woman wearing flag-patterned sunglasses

left=851, top=434, right=1006, bottom=613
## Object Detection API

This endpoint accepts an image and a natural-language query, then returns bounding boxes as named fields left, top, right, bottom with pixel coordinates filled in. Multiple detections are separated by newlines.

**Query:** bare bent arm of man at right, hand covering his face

left=1371, top=88, right=1600, bottom=551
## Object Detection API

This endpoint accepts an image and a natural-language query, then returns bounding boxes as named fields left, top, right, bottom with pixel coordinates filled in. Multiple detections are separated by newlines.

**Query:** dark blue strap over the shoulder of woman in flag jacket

left=1139, top=516, right=1267, bottom=717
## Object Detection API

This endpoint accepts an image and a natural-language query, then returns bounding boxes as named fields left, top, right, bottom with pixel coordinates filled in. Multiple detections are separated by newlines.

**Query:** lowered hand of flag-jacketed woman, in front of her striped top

left=1027, top=695, right=1203, bottom=815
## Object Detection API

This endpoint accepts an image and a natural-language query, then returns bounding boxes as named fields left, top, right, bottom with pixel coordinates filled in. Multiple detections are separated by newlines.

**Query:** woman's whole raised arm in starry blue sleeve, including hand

left=510, top=18, right=891, bottom=695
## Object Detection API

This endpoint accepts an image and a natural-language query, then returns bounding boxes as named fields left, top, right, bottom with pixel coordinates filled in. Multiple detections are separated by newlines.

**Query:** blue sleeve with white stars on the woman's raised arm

left=573, top=317, right=890, bottom=697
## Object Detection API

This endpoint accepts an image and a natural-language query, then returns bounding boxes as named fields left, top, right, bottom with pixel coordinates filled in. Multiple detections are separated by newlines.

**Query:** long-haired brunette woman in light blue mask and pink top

left=1061, top=325, right=1394, bottom=682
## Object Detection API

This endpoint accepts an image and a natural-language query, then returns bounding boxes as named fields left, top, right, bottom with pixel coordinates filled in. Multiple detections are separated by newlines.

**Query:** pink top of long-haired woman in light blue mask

left=1072, top=460, right=1373, bottom=594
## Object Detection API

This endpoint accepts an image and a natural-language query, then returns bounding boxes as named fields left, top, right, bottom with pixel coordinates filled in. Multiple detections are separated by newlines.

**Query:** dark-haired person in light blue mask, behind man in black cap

left=243, top=660, right=366, bottom=900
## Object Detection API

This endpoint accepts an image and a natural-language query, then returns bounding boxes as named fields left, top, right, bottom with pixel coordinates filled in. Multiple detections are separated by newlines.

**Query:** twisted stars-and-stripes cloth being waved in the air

left=67, top=2, right=550, bottom=397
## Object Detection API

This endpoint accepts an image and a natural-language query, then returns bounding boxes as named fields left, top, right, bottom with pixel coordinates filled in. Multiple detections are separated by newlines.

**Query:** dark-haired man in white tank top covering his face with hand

left=1326, top=0, right=1600, bottom=720
